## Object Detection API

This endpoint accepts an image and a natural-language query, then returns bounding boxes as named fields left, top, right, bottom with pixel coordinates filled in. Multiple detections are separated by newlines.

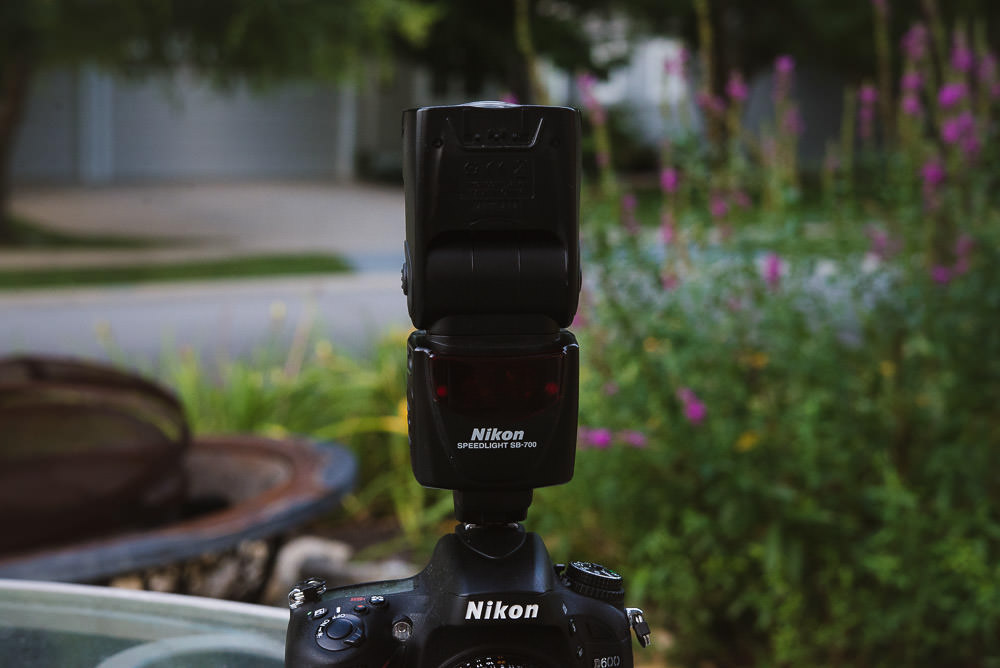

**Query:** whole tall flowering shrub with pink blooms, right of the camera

left=532, top=2, right=1000, bottom=667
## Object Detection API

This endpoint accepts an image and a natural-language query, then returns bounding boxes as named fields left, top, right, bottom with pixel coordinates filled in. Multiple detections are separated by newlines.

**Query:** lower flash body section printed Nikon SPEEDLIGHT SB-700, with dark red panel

left=407, top=330, right=579, bottom=500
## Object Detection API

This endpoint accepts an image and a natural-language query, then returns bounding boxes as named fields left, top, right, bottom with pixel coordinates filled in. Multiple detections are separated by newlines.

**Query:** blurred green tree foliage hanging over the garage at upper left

left=0, top=0, right=437, bottom=239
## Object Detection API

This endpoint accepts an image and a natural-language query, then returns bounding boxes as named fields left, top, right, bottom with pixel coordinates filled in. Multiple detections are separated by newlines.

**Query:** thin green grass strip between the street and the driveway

left=0, top=253, right=351, bottom=290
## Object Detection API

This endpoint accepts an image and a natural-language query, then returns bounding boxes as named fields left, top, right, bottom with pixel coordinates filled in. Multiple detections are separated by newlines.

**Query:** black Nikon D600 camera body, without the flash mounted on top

left=285, top=526, right=633, bottom=668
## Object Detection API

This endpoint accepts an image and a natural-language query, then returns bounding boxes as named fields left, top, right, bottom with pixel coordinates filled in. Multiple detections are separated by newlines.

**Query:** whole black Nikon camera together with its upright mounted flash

left=285, top=102, right=649, bottom=668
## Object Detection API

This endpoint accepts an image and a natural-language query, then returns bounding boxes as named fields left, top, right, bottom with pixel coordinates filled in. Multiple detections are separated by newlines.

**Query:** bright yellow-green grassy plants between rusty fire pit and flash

left=159, top=331, right=451, bottom=551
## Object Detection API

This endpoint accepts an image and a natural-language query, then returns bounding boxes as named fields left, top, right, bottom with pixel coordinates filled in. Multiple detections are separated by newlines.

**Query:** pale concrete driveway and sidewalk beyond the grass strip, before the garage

left=6, top=182, right=404, bottom=271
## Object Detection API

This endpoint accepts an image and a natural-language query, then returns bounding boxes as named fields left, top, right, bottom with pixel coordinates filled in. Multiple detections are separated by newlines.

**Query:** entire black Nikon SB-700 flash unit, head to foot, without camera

left=403, top=102, right=581, bottom=522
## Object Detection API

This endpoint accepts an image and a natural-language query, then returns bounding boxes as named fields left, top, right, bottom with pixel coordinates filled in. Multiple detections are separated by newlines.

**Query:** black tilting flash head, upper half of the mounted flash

left=403, top=102, right=581, bottom=335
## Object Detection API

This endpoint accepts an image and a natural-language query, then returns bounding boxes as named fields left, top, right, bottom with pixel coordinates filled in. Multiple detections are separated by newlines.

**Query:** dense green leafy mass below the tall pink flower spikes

left=533, top=223, right=1000, bottom=666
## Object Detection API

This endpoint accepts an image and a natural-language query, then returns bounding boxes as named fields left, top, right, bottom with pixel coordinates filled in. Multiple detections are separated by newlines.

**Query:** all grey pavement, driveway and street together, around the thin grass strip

left=0, top=183, right=409, bottom=360
